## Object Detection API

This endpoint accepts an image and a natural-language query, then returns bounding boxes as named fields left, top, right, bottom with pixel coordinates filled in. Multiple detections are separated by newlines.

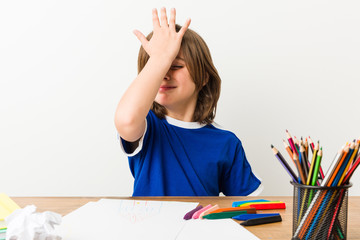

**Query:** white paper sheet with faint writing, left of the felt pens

left=59, top=199, right=198, bottom=240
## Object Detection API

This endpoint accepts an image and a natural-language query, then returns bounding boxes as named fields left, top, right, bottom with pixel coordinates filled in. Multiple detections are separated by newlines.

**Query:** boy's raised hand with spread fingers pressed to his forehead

left=134, top=7, right=191, bottom=61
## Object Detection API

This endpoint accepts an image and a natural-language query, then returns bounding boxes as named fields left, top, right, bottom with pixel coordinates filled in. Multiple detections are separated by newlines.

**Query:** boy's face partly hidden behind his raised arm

left=155, top=51, right=198, bottom=118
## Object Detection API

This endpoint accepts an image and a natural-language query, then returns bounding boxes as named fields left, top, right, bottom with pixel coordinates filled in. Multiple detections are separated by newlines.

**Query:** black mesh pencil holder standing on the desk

left=291, top=182, right=352, bottom=240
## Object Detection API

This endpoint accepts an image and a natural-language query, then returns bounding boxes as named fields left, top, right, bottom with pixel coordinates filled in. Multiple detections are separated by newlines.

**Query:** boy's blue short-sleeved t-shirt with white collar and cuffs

left=121, top=111, right=261, bottom=196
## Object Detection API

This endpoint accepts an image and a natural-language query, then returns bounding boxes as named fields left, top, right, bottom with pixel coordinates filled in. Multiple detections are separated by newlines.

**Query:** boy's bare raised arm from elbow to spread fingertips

left=115, top=8, right=190, bottom=142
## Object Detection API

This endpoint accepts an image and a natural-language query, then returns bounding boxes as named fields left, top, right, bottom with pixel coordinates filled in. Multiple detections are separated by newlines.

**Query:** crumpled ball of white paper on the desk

left=5, top=205, right=61, bottom=240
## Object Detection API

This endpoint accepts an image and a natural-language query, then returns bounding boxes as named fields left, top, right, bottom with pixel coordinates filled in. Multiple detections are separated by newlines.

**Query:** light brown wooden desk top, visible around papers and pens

left=12, top=196, right=360, bottom=240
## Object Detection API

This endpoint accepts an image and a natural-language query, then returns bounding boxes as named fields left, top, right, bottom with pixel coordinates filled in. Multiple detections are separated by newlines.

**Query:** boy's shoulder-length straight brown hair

left=138, top=24, right=221, bottom=124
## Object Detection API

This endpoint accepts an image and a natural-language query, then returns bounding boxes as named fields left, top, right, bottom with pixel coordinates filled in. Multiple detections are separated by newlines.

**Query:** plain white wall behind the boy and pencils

left=0, top=0, right=360, bottom=196
